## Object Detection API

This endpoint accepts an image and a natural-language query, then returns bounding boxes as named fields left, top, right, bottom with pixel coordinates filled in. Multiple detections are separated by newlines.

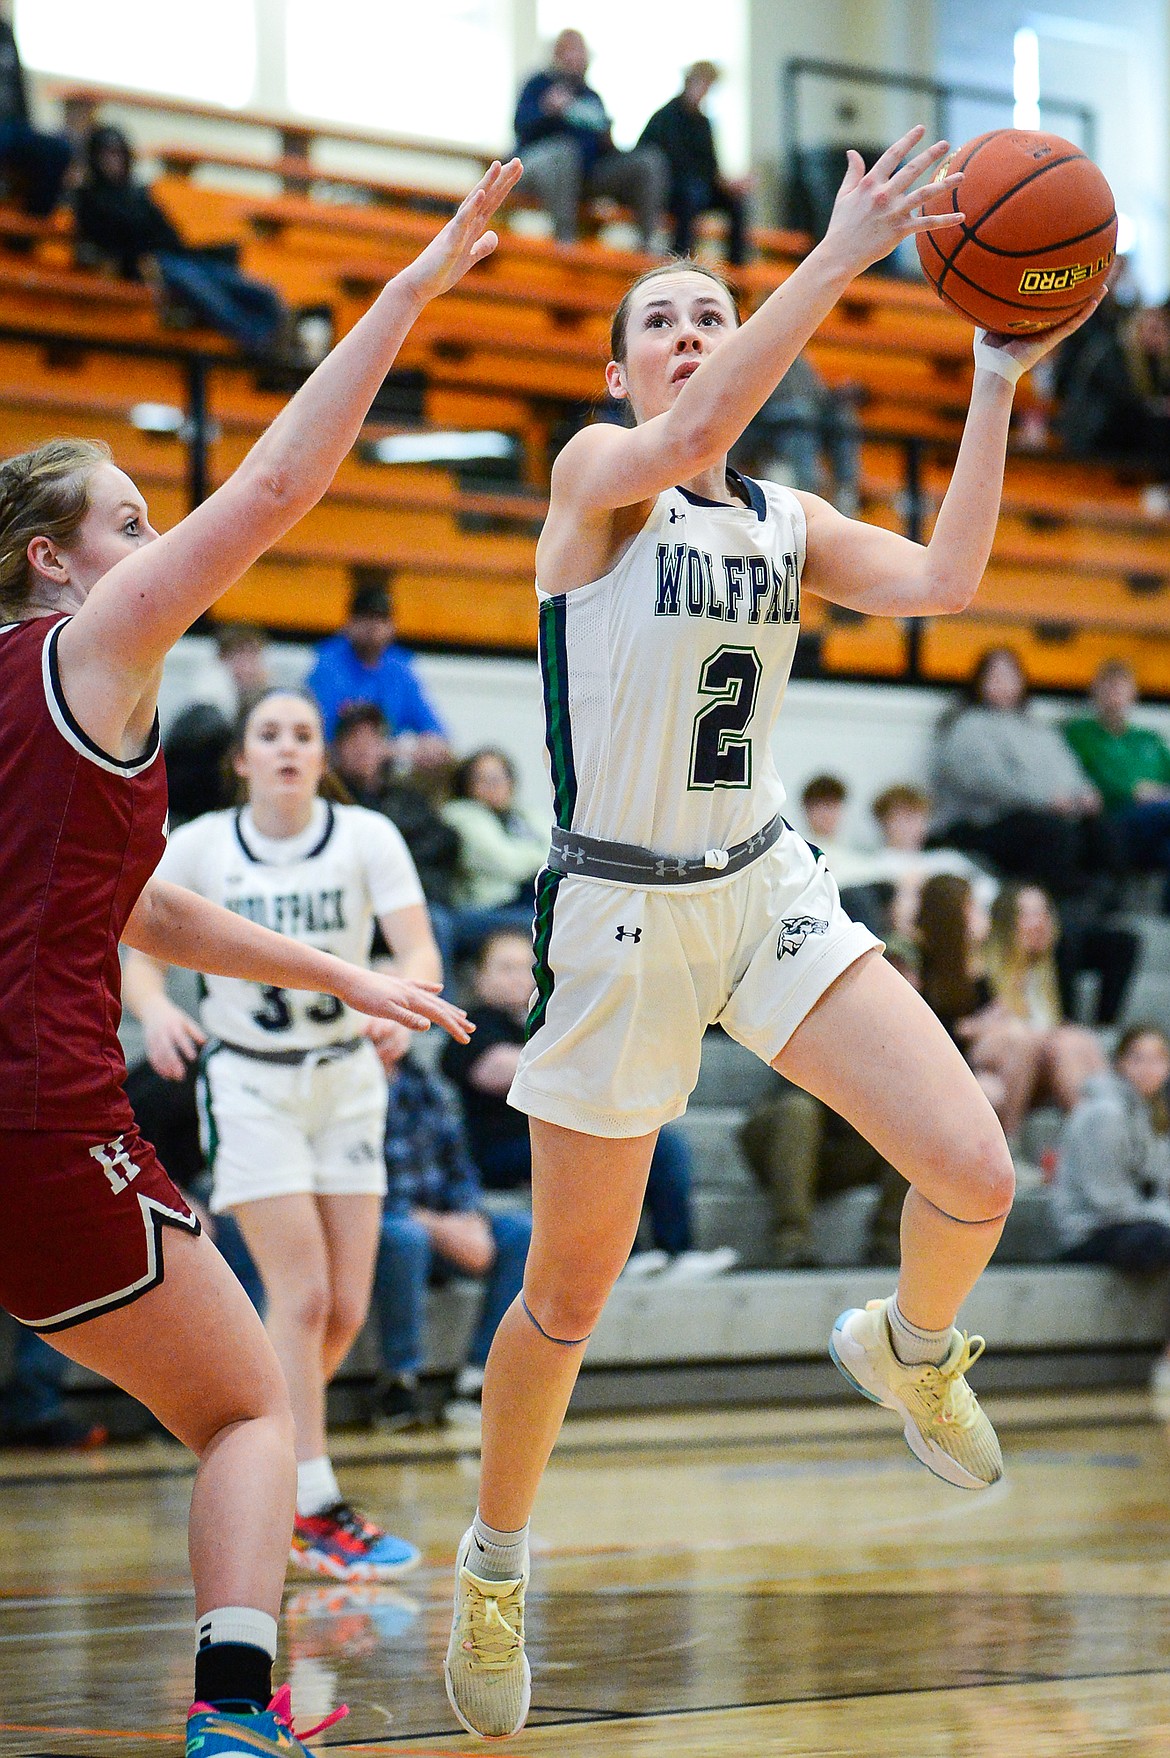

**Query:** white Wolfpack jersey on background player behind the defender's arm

left=158, top=800, right=423, bottom=1050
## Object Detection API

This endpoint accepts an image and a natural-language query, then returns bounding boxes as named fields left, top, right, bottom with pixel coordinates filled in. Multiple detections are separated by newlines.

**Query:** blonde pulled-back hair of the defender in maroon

left=0, top=440, right=111, bottom=621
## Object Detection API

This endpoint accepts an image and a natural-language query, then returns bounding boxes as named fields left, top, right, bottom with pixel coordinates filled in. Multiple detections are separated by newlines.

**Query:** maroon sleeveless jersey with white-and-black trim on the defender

left=0, top=617, right=167, bottom=1136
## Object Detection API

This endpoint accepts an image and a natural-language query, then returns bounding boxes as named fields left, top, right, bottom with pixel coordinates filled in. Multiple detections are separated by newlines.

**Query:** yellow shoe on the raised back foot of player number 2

left=829, top=1301, right=1003, bottom=1489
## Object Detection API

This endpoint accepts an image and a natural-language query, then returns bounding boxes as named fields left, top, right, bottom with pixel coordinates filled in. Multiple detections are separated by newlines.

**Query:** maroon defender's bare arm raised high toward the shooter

left=54, top=160, right=520, bottom=724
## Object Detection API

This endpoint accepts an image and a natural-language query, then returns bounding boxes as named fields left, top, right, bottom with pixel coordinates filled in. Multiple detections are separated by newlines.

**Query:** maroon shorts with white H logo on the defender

left=0, top=1127, right=199, bottom=1331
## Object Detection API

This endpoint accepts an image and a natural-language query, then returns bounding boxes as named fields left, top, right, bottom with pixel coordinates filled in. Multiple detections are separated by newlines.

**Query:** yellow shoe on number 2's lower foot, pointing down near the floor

left=443, top=1531, right=532, bottom=1740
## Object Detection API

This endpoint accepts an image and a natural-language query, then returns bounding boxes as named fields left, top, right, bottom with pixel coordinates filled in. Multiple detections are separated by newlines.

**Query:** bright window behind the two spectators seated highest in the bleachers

left=536, top=0, right=748, bottom=176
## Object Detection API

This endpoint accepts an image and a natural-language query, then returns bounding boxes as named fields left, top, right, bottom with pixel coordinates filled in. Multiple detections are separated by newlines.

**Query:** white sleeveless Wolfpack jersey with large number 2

left=538, top=478, right=805, bottom=858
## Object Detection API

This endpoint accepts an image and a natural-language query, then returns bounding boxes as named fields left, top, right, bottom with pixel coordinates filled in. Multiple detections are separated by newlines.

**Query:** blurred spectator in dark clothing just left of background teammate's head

left=163, top=622, right=272, bottom=826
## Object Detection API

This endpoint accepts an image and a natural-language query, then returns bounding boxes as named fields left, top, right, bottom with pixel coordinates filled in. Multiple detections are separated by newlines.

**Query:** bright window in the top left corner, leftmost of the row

left=14, top=0, right=256, bottom=109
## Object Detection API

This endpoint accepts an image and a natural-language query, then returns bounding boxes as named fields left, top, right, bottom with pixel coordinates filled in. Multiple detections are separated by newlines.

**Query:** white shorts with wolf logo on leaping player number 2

left=508, top=826, right=882, bottom=1136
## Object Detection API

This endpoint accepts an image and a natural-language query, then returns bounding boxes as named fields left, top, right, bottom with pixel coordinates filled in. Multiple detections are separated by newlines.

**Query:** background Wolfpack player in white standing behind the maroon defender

left=125, top=689, right=443, bottom=1580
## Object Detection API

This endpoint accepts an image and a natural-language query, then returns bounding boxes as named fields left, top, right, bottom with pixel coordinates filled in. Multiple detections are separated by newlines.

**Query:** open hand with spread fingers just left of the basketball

left=824, top=125, right=963, bottom=274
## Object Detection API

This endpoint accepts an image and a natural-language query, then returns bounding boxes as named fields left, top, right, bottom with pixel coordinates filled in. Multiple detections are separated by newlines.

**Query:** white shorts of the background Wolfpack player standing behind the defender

left=199, top=1042, right=386, bottom=1215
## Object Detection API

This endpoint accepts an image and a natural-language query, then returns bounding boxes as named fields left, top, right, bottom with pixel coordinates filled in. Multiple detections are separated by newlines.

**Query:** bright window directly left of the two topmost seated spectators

left=286, top=0, right=515, bottom=148
